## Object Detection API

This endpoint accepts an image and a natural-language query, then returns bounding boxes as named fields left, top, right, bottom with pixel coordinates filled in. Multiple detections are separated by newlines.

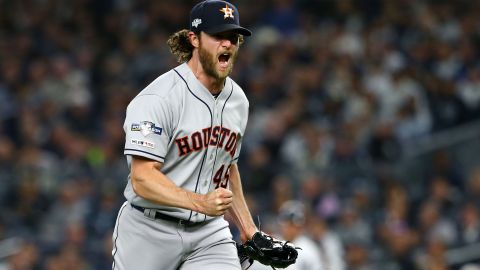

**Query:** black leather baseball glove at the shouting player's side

left=237, top=232, right=298, bottom=269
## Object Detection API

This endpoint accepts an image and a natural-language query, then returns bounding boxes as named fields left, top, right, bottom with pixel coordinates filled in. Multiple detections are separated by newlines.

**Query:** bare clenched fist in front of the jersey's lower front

left=199, top=188, right=233, bottom=216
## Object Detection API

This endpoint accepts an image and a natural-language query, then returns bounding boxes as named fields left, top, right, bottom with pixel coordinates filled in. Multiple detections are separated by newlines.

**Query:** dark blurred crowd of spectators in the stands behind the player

left=0, top=0, right=480, bottom=270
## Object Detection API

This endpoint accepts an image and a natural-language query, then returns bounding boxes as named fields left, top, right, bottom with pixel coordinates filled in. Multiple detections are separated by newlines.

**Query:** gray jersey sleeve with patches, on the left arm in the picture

left=123, top=95, right=172, bottom=163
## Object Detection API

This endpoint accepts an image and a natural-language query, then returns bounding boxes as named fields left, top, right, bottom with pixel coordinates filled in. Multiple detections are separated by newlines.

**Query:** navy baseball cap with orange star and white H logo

left=190, top=0, right=252, bottom=36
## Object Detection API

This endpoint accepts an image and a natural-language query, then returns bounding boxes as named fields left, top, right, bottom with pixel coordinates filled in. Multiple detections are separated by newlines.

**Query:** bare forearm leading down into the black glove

left=229, top=164, right=257, bottom=241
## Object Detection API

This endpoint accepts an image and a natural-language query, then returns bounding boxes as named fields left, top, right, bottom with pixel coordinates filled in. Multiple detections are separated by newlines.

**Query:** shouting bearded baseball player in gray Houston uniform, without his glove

left=112, top=0, right=257, bottom=270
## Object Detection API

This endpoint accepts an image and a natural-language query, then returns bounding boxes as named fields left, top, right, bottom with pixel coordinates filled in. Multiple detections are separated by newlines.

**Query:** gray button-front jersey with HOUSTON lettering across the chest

left=123, top=64, right=248, bottom=222
